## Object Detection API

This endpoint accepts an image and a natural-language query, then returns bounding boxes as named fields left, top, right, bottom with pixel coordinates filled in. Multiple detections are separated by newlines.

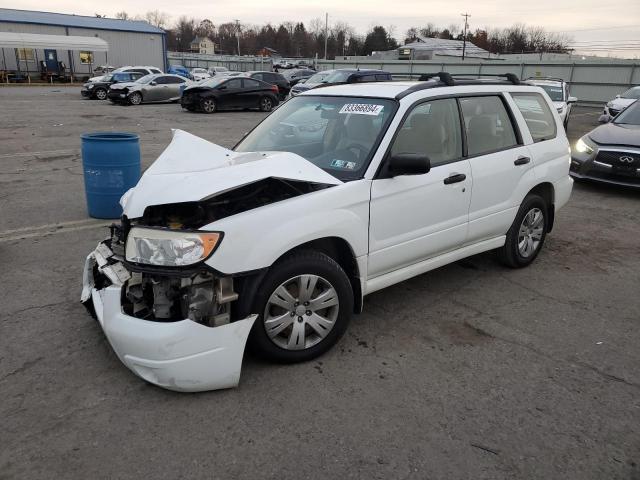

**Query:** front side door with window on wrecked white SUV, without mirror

left=368, top=98, right=472, bottom=278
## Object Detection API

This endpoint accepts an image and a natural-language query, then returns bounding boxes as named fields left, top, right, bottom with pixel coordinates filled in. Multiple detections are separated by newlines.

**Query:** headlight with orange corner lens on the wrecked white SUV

left=125, top=227, right=222, bottom=267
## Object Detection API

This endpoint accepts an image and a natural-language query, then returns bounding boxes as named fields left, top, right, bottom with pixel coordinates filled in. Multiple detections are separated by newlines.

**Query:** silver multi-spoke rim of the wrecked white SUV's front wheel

left=263, top=275, right=340, bottom=350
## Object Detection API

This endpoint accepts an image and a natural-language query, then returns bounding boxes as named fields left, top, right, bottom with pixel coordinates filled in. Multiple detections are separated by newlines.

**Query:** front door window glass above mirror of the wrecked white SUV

left=391, top=98, right=462, bottom=167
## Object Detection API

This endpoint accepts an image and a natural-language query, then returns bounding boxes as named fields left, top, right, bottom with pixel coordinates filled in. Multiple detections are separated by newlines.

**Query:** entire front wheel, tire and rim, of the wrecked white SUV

left=249, top=251, right=353, bottom=363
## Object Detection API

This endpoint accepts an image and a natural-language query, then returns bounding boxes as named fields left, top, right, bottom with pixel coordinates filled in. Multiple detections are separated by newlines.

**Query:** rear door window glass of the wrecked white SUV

left=460, top=96, right=518, bottom=155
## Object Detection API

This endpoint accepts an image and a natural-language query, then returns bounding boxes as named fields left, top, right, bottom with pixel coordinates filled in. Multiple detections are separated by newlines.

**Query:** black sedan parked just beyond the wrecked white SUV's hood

left=180, top=76, right=280, bottom=113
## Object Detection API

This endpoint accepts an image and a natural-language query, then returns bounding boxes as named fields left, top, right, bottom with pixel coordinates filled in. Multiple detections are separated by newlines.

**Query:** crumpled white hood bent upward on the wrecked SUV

left=121, top=130, right=342, bottom=218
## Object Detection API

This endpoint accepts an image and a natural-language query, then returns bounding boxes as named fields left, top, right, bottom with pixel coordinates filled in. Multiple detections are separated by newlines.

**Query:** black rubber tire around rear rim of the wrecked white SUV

left=497, top=194, right=549, bottom=268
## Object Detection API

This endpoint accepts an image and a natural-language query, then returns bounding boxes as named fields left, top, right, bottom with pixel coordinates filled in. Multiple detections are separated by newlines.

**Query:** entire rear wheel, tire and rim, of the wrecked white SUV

left=498, top=194, right=548, bottom=268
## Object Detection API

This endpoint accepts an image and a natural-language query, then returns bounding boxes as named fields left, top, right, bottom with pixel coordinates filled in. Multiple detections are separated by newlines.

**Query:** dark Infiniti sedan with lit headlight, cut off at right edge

left=570, top=100, right=640, bottom=187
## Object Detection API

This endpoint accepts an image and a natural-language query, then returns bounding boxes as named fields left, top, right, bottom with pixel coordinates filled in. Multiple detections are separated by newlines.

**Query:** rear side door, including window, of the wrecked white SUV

left=460, top=94, right=535, bottom=244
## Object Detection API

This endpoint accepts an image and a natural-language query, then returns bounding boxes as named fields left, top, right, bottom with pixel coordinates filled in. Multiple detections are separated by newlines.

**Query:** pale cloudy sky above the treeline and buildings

left=0, top=0, right=640, bottom=58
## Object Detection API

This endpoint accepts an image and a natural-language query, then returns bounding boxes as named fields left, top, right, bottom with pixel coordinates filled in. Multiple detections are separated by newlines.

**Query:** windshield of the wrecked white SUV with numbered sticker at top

left=235, top=96, right=397, bottom=181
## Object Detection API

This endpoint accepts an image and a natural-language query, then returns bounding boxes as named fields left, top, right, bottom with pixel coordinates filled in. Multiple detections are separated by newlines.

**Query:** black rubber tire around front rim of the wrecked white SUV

left=246, top=250, right=353, bottom=363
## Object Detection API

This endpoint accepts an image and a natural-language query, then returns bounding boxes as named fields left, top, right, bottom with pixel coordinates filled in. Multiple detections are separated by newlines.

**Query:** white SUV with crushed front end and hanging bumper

left=81, top=73, right=572, bottom=391
